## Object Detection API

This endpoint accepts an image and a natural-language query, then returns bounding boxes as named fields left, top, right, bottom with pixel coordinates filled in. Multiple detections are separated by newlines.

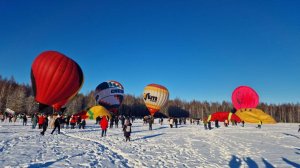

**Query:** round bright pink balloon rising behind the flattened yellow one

left=231, top=86, right=259, bottom=110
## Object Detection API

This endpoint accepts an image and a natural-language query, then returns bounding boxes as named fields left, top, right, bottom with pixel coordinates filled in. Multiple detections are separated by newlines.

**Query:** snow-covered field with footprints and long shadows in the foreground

left=0, top=120, right=300, bottom=168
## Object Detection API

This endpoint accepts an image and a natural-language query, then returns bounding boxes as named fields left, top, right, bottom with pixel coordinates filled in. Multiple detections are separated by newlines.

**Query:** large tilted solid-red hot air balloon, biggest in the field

left=31, top=51, right=83, bottom=106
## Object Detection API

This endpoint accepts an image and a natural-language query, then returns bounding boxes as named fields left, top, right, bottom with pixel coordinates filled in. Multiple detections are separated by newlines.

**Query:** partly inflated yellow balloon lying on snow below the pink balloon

left=235, top=108, right=276, bottom=124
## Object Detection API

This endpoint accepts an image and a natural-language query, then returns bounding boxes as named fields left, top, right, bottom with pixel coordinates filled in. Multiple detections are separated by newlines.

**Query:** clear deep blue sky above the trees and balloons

left=0, top=0, right=300, bottom=103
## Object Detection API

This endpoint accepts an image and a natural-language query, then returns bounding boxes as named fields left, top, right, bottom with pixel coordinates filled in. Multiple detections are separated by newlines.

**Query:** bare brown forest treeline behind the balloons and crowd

left=0, top=76, right=300, bottom=122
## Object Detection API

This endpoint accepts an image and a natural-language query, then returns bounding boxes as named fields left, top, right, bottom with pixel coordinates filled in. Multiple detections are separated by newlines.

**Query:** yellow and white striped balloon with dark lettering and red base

left=143, top=84, right=169, bottom=116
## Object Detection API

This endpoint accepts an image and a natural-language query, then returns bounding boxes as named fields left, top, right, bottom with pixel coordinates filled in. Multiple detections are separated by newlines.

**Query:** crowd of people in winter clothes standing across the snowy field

left=0, top=113, right=300, bottom=141
